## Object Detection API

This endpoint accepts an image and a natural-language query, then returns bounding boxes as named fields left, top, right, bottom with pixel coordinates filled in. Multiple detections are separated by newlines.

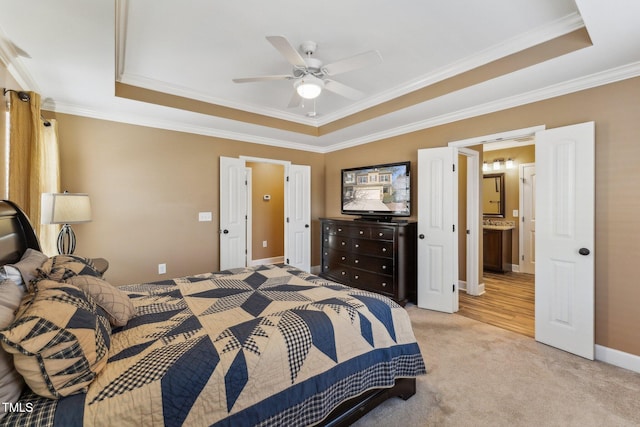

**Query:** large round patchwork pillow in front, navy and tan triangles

left=0, top=280, right=111, bottom=398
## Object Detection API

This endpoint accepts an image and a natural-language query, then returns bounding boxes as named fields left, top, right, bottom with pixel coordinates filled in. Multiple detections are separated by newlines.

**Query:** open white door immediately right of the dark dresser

left=418, top=147, right=458, bottom=313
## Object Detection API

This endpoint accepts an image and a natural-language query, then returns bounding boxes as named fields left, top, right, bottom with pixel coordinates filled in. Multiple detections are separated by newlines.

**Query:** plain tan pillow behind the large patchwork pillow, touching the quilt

left=66, top=275, right=136, bottom=326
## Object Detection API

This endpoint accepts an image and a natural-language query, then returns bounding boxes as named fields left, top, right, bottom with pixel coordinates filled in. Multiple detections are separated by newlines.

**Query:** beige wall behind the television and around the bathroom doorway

left=325, top=78, right=640, bottom=355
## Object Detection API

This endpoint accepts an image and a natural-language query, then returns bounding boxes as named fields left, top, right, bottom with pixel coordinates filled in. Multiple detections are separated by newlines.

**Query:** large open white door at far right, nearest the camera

left=535, top=122, right=595, bottom=360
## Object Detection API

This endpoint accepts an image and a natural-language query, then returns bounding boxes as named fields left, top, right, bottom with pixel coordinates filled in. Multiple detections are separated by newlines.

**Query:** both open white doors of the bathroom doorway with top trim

left=418, top=122, right=595, bottom=360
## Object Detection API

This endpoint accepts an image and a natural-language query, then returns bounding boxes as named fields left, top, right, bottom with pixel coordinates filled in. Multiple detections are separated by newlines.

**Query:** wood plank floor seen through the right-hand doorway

left=457, top=271, right=535, bottom=337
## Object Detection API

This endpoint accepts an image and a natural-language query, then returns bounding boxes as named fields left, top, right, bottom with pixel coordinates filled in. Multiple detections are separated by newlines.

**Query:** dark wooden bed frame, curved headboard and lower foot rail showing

left=0, top=200, right=416, bottom=427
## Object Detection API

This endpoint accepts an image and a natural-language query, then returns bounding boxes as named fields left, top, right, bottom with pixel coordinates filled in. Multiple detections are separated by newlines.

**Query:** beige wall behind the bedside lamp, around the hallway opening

left=51, top=112, right=325, bottom=284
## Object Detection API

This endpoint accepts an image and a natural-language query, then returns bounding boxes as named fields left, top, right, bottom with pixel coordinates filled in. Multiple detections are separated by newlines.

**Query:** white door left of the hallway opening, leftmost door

left=220, top=157, right=247, bottom=270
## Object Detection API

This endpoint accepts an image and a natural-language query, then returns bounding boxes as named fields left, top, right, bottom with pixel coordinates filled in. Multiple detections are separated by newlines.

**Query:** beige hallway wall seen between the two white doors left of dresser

left=247, top=162, right=284, bottom=260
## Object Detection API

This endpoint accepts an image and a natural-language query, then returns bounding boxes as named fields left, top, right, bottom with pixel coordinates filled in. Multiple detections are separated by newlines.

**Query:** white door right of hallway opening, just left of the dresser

left=284, top=165, right=311, bottom=272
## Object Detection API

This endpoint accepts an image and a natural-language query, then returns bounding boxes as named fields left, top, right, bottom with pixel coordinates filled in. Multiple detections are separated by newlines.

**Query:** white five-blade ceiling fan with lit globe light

left=233, top=36, right=382, bottom=108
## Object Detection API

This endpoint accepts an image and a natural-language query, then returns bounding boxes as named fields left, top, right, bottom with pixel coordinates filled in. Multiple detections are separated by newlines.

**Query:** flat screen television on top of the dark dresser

left=341, top=162, right=411, bottom=220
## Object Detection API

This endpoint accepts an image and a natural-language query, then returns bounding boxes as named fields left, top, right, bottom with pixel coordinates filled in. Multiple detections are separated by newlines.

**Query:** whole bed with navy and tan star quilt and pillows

left=0, top=201, right=426, bottom=427
